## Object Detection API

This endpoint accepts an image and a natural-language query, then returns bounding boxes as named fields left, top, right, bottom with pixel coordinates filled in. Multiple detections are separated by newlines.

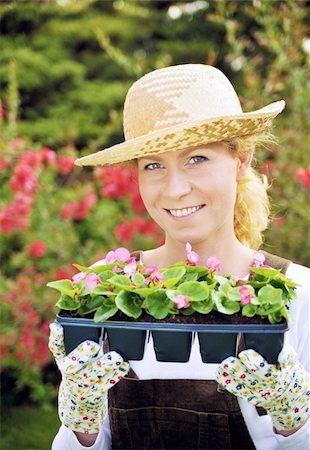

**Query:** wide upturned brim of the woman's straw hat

left=75, top=100, right=285, bottom=166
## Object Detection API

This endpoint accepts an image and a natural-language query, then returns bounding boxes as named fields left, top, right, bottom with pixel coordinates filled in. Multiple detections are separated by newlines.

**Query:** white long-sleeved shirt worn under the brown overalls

left=52, top=263, right=310, bottom=450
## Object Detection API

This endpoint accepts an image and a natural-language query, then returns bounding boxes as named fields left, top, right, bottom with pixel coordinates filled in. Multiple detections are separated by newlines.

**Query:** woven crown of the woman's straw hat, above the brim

left=124, top=64, right=242, bottom=140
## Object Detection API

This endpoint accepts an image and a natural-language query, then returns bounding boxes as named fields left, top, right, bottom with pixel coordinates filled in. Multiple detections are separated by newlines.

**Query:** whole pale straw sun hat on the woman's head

left=75, top=64, right=285, bottom=166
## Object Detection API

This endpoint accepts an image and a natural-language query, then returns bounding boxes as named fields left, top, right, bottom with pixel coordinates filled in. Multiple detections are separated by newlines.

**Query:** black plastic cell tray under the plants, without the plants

left=56, top=315, right=288, bottom=364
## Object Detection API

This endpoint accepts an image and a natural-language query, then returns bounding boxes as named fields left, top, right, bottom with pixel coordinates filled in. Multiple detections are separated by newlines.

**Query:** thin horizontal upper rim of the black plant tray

left=56, top=315, right=289, bottom=333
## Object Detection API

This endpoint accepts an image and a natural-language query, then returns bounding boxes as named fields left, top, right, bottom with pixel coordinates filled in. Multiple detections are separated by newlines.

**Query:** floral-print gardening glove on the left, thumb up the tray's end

left=48, top=323, right=129, bottom=433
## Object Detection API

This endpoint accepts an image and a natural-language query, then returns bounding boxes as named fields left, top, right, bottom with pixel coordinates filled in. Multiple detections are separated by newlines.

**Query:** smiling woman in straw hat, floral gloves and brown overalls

left=50, top=64, right=309, bottom=450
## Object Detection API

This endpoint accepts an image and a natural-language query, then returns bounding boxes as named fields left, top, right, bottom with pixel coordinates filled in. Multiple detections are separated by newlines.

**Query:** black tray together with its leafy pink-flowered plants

left=48, top=244, right=296, bottom=362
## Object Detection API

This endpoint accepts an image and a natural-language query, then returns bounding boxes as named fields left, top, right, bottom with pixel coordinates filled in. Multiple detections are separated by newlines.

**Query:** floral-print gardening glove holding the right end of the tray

left=216, top=346, right=310, bottom=431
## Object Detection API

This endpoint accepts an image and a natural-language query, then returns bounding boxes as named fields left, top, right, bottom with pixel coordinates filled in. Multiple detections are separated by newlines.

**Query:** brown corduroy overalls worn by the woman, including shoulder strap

left=109, top=252, right=290, bottom=450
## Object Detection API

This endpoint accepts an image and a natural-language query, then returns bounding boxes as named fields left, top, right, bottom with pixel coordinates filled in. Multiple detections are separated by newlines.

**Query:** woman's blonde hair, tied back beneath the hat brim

left=227, top=134, right=275, bottom=249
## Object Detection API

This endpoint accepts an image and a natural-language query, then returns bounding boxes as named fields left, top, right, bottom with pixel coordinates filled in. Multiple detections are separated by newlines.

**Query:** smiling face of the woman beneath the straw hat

left=138, top=143, right=246, bottom=244
